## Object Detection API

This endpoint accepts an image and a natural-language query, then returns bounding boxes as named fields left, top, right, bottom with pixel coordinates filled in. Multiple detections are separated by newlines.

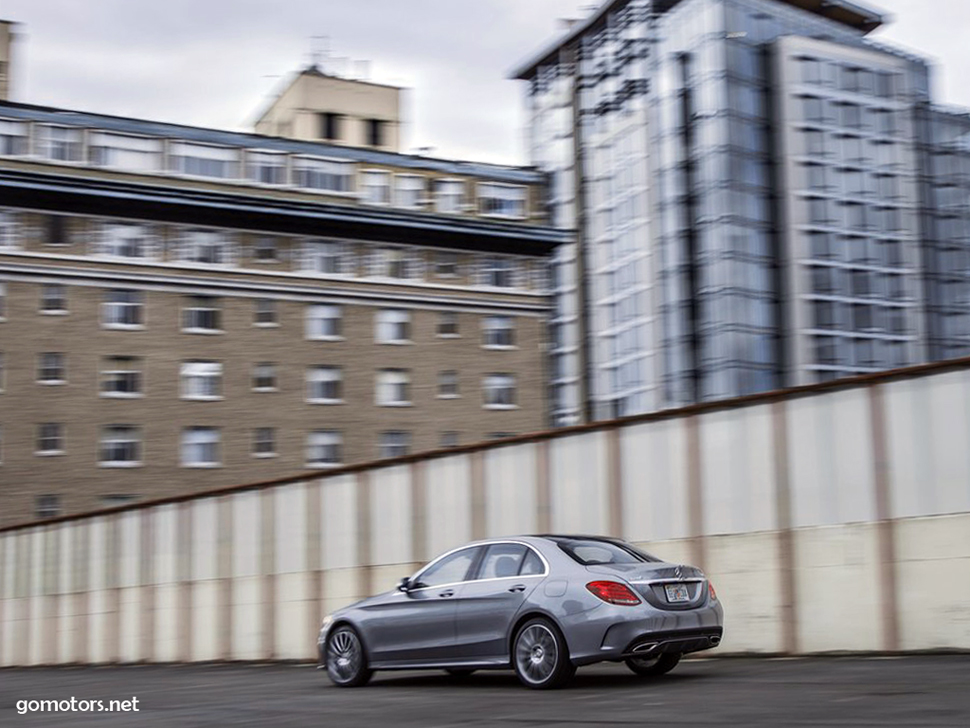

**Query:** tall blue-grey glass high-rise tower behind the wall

left=514, top=0, right=970, bottom=424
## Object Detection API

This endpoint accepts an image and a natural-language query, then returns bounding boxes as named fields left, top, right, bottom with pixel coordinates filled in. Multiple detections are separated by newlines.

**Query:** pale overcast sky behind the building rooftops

left=0, top=0, right=970, bottom=164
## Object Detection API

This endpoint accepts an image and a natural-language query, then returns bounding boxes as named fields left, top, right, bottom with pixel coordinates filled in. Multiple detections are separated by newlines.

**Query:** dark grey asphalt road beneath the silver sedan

left=0, top=656, right=970, bottom=728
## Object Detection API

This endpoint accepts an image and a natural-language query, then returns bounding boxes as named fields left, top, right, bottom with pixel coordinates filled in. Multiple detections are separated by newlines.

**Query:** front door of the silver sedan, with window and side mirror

left=368, top=546, right=481, bottom=665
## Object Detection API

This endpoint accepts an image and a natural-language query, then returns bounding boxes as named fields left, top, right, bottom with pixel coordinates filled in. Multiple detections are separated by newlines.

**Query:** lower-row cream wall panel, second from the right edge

left=793, top=524, right=882, bottom=653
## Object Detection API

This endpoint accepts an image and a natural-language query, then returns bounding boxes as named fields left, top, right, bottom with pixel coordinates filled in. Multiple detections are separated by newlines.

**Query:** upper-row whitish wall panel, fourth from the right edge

left=620, top=420, right=689, bottom=542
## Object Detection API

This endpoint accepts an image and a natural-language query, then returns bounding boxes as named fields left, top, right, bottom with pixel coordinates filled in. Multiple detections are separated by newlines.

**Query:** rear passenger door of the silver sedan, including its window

left=456, top=542, right=546, bottom=660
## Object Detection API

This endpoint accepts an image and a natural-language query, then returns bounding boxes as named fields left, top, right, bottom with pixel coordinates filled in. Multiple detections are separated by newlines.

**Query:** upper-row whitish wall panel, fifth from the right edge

left=549, top=432, right=609, bottom=533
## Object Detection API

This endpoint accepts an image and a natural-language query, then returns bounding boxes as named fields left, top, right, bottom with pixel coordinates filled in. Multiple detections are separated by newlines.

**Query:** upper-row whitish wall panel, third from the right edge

left=700, top=406, right=776, bottom=534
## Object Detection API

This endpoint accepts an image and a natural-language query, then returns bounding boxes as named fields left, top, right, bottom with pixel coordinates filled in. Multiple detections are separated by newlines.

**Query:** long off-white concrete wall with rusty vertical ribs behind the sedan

left=0, top=367, right=970, bottom=666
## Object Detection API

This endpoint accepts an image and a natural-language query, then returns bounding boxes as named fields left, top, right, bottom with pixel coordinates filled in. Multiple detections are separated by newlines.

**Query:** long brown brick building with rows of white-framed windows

left=0, top=26, right=569, bottom=523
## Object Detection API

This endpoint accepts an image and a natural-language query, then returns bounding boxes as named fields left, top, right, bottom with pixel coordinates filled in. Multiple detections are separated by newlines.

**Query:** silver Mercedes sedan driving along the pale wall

left=317, top=536, right=723, bottom=689
